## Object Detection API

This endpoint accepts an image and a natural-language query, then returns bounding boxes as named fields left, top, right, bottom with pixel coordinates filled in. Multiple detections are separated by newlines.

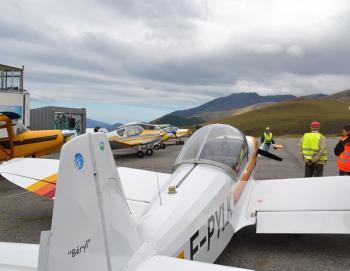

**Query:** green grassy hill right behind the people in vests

left=215, top=99, right=350, bottom=136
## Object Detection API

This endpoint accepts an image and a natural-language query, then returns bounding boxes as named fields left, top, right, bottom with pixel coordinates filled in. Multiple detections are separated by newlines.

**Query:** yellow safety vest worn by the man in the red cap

left=301, top=133, right=328, bottom=161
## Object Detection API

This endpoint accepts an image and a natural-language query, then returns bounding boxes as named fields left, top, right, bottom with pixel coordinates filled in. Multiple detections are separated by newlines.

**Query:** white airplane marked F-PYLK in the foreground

left=0, top=124, right=350, bottom=271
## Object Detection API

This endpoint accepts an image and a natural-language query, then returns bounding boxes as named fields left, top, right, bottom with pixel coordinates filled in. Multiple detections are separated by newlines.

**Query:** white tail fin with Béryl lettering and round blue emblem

left=39, top=133, right=140, bottom=271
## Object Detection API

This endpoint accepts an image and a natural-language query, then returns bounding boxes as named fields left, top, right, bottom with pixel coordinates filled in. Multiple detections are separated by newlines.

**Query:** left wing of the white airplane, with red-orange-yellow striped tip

left=0, top=158, right=170, bottom=203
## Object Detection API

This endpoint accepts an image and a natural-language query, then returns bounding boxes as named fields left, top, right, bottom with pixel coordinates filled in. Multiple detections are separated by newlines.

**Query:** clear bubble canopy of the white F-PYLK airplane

left=174, top=124, right=248, bottom=175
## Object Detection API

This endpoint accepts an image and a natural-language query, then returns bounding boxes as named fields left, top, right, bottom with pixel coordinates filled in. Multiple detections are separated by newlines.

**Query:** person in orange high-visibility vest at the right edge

left=334, top=125, right=350, bottom=176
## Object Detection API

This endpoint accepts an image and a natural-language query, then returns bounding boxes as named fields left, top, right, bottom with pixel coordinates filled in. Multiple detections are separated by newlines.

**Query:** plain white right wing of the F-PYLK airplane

left=247, top=176, right=350, bottom=233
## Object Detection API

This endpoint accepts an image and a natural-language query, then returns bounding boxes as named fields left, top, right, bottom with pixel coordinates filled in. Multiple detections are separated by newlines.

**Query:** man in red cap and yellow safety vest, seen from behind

left=300, top=121, right=328, bottom=177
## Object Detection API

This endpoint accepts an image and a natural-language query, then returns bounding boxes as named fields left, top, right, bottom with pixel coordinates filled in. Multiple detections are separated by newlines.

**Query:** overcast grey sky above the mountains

left=0, top=0, right=350, bottom=122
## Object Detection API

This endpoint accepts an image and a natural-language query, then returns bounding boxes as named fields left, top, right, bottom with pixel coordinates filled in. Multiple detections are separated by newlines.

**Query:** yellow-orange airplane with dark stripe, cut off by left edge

left=0, top=112, right=73, bottom=161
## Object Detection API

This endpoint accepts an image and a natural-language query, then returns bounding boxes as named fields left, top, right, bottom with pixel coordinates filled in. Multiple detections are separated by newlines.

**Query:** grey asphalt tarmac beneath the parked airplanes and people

left=0, top=138, right=350, bottom=271
